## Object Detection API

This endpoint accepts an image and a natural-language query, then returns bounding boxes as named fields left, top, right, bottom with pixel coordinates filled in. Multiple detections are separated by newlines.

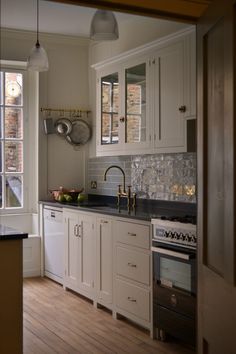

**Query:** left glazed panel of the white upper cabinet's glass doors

left=101, top=73, right=119, bottom=145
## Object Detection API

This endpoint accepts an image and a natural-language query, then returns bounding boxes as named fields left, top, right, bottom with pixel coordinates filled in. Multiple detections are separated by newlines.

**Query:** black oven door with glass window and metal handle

left=152, top=241, right=196, bottom=296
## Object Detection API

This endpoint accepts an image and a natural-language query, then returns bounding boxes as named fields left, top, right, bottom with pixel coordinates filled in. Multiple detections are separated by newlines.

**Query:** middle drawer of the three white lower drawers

left=116, top=247, right=150, bottom=285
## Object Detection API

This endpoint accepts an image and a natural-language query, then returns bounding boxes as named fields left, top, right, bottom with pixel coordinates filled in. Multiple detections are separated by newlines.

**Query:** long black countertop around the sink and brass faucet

left=39, top=196, right=196, bottom=221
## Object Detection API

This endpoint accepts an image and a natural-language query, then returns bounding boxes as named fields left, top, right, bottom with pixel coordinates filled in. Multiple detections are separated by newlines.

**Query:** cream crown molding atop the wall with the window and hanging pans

left=1, top=28, right=90, bottom=46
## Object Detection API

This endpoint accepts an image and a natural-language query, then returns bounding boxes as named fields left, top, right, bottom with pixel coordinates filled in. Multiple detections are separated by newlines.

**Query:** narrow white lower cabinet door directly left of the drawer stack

left=96, top=215, right=113, bottom=308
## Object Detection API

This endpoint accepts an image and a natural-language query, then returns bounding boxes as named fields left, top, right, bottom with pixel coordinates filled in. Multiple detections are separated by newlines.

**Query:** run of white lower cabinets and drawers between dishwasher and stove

left=60, top=208, right=152, bottom=333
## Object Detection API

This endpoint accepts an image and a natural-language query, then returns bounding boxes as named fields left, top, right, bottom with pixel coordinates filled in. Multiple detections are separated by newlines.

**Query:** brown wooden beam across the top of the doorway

left=48, top=0, right=211, bottom=23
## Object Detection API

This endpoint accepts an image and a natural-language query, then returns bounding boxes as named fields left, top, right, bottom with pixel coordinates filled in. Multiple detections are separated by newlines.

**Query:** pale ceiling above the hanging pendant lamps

left=1, top=0, right=160, bottom=38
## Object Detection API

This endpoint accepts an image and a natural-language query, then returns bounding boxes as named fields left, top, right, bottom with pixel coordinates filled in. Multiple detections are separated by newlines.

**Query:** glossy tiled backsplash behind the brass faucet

left=87, top=153, right=196, bottom=202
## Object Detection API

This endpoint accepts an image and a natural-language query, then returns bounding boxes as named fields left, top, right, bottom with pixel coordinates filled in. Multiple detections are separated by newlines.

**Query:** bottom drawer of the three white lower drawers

left=116, top=279, right=150, bottom=322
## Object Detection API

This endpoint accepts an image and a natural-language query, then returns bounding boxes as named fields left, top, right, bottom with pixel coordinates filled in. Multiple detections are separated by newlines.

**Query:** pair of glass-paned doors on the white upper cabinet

left=97, top=59, right=149, bottom=155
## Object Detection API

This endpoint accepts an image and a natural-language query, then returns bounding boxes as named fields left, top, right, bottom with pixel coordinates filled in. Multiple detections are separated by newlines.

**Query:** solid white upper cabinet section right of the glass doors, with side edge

left=152, top=33, right=196, bottom=152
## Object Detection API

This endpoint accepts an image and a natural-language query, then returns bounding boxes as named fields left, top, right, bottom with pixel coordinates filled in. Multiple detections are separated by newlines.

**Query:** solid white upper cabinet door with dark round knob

left=154, top=42, right=185, bottom=148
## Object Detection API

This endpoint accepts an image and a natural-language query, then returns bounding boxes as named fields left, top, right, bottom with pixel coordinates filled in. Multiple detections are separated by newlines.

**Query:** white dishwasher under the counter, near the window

left=43, top=206, right=64, bottom=284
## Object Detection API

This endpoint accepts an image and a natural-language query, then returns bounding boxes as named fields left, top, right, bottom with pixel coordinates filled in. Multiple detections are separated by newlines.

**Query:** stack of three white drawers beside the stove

left=113, top=220, right=151, bottom=330
